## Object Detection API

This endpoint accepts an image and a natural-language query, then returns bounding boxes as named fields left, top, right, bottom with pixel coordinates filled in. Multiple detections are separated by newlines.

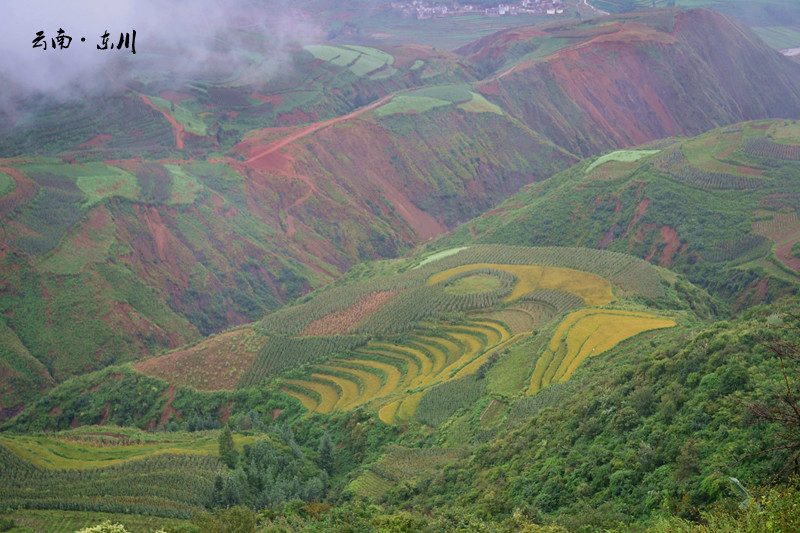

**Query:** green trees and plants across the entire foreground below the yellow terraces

left=0, top=296, right=800, bottom=532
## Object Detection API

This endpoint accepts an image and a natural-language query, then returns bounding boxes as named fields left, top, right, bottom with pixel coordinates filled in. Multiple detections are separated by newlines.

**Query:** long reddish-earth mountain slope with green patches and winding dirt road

left=0, top=10, right=800, bottom=416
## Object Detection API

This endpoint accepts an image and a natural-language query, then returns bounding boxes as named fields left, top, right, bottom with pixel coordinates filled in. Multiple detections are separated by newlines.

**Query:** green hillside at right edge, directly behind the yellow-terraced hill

left=440, top=121, right=800, bottom=308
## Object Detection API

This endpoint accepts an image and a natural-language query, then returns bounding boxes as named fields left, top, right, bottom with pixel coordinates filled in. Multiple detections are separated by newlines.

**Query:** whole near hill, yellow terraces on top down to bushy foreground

left=0, top=245, right=798, bottom=531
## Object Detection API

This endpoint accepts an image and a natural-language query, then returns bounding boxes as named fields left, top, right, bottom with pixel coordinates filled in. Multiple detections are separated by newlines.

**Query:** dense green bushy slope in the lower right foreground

left=370, top=302, right=797, bottom=530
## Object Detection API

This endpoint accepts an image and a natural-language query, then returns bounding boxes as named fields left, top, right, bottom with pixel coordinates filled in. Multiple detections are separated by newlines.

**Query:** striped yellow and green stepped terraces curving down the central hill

left=284, top=319, right=524, bottom=424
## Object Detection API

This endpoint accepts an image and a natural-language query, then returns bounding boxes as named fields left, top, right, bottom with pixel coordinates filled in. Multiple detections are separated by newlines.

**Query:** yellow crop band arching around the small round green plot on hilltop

left=428, top=263, right=616, bottom=305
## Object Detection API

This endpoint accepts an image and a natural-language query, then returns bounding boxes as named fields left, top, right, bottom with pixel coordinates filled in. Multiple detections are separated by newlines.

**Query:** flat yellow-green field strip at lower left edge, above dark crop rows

left=0, top=427, right=254, bottom=469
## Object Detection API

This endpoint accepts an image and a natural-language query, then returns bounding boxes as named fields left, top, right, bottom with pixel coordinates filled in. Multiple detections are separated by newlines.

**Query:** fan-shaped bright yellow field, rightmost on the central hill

left=528, top=309, right=676, bottom=394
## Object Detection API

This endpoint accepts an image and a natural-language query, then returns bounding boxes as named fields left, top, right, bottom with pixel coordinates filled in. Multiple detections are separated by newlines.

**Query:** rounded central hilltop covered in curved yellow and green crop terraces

left=231, top=245, right=674, bottom=424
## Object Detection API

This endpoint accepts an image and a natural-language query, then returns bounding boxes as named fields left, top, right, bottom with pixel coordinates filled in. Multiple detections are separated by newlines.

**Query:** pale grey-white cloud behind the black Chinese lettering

left=0, top=0, right=318, bottom=112
